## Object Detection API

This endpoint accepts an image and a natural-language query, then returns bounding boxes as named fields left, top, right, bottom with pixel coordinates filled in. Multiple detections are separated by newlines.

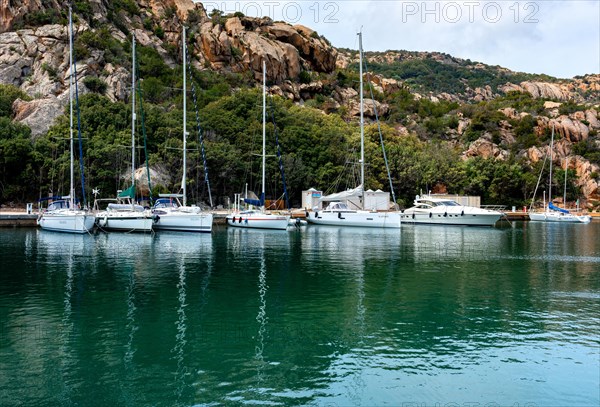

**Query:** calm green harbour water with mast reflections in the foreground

left=0, top=222, right=600, bottom=407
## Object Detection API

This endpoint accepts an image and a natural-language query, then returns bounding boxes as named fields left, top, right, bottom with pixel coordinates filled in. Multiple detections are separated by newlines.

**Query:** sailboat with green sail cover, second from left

left=94, top=36, right=154, bottom=232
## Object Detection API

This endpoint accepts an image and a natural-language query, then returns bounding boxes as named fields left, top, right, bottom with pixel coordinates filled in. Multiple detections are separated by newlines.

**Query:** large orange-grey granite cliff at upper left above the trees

left=0, top=0, right=337, bottom=135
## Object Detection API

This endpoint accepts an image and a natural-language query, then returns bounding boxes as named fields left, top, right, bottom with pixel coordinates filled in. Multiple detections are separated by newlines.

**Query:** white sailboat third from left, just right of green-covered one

left=153, top=27, right=213, bottom=233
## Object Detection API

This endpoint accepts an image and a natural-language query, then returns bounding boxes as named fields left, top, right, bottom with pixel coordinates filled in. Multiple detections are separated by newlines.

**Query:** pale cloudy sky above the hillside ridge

left=202, top=0, right=600, bottom=78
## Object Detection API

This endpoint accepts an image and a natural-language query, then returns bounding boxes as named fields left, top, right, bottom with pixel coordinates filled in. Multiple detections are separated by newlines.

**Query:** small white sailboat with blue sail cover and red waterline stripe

left=226, top=61, right=290, bottom=230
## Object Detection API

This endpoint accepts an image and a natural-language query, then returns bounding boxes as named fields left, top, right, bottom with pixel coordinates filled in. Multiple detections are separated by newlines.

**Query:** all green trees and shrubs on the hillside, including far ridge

left=0, top=6, right=600, bottom=207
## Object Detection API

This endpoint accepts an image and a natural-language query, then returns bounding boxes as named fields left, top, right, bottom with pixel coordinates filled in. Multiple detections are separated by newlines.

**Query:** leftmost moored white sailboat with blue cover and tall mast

left=37, top=7, right=94, bottom=233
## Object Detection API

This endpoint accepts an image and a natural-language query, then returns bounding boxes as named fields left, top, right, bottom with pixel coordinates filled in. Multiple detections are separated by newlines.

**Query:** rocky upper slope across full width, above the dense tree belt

left=0, top=0, right=600, bottom=207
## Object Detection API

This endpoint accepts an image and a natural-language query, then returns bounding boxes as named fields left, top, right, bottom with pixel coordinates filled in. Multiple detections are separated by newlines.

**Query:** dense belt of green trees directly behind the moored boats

left=0, top=82, right=572, bottom=210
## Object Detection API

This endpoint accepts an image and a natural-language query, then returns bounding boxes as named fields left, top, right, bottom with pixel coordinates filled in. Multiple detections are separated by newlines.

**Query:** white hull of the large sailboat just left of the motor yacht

left=306, top=211, right=401, bottom=229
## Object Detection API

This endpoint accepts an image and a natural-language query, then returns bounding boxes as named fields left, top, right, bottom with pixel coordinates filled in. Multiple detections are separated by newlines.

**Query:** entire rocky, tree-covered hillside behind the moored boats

left=0, top=0, right=600, bottom=208
